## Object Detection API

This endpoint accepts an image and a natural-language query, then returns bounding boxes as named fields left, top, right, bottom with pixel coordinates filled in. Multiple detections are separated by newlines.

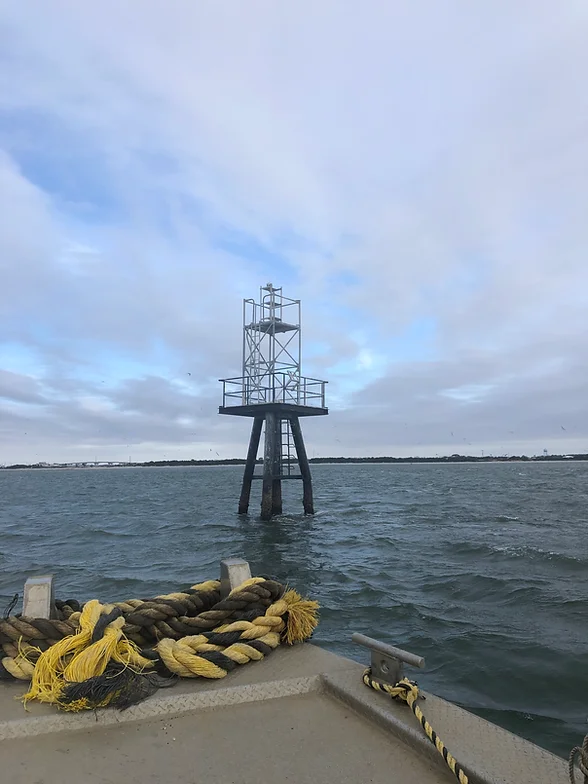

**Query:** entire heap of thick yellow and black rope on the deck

left=0, top=577, right=318, bottom=710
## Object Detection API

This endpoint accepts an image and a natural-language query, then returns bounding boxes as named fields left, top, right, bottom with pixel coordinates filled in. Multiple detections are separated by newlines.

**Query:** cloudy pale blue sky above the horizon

left=0, top=0, right=588, bottom=464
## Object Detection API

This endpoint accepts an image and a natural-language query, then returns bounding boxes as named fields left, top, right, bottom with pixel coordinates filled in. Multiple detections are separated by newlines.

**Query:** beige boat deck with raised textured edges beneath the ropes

left=0, top=644, right=569, bottom=784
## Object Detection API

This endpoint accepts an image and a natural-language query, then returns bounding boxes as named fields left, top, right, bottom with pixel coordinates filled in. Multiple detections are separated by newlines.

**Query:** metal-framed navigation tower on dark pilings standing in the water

left=219, top=283, right=329, bottom=520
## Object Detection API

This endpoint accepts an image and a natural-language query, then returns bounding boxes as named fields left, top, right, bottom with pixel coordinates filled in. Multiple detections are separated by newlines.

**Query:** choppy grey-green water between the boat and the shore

left=0, top=463, right=588, bottom=755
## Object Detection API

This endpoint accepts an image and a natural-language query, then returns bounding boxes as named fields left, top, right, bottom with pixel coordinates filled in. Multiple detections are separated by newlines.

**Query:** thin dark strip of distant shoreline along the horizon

left=0, top=454, right=588, bottom=471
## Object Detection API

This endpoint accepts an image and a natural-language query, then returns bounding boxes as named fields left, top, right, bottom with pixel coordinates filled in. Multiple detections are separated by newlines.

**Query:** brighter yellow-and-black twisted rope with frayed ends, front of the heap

left=8, top=578, right=318, bottom=711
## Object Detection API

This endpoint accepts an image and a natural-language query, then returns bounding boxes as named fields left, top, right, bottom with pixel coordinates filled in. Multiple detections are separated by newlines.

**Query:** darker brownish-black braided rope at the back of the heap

left=0, top=577, right=284, bottom=680
